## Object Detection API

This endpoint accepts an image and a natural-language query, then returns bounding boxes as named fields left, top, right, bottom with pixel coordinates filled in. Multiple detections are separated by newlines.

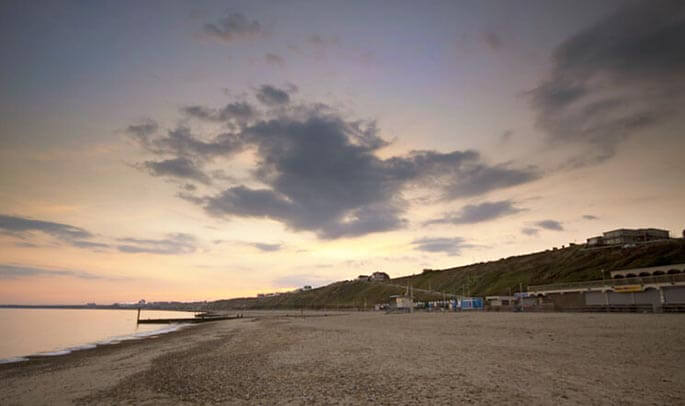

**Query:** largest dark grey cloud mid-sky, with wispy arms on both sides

left=131, top=85, right=540, bottom=239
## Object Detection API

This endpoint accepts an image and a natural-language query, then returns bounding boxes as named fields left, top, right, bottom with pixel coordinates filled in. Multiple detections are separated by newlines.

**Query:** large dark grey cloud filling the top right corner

left=531, top=0, right=685, bottom=166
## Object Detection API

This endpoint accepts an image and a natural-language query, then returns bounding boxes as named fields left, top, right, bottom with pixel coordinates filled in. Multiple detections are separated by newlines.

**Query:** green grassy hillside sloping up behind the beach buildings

left=207, top=239, right=685, bottom=310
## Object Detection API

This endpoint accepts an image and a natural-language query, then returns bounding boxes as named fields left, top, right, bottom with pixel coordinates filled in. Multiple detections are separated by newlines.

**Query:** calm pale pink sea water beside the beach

left=0, top=309, right=193, bottom=363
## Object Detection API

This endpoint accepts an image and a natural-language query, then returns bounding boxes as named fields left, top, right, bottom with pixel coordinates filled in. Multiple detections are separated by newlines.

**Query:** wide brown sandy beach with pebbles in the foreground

left=0, top=312, right=685, bottom=405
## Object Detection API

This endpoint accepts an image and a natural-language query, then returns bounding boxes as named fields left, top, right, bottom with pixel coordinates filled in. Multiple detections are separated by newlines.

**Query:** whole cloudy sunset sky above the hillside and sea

left=0, top=0, right=685, bottom=304
